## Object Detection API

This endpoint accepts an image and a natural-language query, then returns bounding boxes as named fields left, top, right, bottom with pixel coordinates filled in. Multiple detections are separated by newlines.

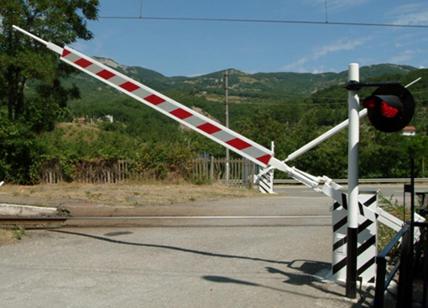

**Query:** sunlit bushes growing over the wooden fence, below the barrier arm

left=33, top=122, right=194, bottom=181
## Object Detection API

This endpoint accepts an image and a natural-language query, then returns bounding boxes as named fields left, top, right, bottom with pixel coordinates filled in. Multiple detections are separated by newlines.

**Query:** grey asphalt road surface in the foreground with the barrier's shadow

left=0, top=185, right=422, bottom=308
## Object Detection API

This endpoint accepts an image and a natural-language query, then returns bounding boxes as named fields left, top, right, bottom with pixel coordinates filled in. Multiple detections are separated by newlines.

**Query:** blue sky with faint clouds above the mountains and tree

left=72, top=0, right=428, bottom=76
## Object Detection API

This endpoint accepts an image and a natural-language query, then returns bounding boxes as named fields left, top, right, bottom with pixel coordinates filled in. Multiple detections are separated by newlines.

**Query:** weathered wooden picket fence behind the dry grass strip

left=41, top=157, right=257, bottom=186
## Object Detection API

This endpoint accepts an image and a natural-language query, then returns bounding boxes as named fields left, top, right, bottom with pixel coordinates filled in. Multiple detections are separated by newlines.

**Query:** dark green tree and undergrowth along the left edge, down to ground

left=0, top=0, right=98, bottom=184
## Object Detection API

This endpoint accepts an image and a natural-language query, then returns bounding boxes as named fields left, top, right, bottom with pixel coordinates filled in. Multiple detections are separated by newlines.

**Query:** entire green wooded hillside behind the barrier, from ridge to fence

left=0, top=59, right=428, bottom=183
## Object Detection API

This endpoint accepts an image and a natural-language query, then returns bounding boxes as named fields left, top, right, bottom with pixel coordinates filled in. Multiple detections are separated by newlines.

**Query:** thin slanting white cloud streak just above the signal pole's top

left=283, top=38, right=370, bottom=72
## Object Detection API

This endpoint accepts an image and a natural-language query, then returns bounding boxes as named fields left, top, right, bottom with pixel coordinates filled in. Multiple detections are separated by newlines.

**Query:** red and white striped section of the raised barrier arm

left=61, top=46, right=273, bottom=168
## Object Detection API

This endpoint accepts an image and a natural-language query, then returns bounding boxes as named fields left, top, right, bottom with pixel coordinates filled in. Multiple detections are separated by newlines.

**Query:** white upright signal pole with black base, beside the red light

left=346, top=63, right=360, bottom=298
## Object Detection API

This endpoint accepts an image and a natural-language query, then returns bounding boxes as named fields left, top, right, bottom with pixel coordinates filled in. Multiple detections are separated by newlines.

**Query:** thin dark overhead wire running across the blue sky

left=99, top=15, right=428, bottom=29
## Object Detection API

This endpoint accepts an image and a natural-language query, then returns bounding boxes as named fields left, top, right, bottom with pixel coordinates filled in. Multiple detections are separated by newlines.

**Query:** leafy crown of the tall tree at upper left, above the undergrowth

left=0, top=0, right=98, bottom=125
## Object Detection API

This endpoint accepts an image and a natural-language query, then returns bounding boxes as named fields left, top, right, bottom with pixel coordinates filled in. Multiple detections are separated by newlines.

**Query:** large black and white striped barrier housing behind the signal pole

left=332, top=192, right=377, bottom=284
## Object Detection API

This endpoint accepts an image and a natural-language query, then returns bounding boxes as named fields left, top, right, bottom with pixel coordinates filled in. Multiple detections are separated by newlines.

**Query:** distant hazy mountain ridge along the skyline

left=69, top=57, right=416, bottom=107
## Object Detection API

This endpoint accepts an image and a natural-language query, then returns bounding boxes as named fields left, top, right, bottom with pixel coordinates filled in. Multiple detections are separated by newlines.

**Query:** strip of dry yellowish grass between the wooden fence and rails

left=0, top=183, right=258, bottom=207
